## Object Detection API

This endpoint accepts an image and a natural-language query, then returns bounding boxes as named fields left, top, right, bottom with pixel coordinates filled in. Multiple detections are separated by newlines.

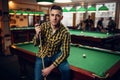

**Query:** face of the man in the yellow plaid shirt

left=50, top=9, right=63, bottom=26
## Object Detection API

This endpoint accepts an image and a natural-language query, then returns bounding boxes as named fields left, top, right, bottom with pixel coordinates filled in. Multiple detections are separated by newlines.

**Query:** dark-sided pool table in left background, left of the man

left=10, top=26, right=35, bottom=44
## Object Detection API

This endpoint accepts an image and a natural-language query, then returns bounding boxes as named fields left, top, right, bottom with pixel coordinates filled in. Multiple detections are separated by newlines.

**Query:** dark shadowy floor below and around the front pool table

left=0, top=55, right=120, bottom=80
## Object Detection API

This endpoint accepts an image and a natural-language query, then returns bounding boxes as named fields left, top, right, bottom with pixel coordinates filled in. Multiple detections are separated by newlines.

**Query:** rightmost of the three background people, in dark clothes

left=108, top=17, right=116, bottom=33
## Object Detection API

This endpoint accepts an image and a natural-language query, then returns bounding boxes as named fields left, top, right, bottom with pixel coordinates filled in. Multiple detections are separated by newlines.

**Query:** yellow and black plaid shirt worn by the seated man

left=33, top=22, right=71, bottom=66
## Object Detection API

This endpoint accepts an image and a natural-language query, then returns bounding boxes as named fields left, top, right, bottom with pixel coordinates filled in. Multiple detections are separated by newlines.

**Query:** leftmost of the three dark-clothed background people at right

left=84, top=15, right=94, bottom=31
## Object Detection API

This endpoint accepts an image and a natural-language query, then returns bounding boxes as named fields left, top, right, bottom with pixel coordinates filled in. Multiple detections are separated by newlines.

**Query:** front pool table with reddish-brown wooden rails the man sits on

left=10, top=42, right=120, bottom=80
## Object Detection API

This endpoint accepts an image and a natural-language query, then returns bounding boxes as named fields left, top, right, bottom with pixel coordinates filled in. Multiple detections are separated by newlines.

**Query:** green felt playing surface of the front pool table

left=17, top=43, right=120, bottom=77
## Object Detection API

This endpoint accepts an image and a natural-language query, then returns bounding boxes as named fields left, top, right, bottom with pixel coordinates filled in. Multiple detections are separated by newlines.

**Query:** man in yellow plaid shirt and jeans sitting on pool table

left=33, top=5, right=71, bottom=80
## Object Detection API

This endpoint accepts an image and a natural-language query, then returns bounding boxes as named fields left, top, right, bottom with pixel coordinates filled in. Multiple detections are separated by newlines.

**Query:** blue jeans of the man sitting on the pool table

left=34, top=52, right=70, bottom=80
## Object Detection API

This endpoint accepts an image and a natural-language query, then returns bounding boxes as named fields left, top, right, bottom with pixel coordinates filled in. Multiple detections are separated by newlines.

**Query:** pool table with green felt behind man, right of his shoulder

left=69, top=29, right=114, bottom=47
